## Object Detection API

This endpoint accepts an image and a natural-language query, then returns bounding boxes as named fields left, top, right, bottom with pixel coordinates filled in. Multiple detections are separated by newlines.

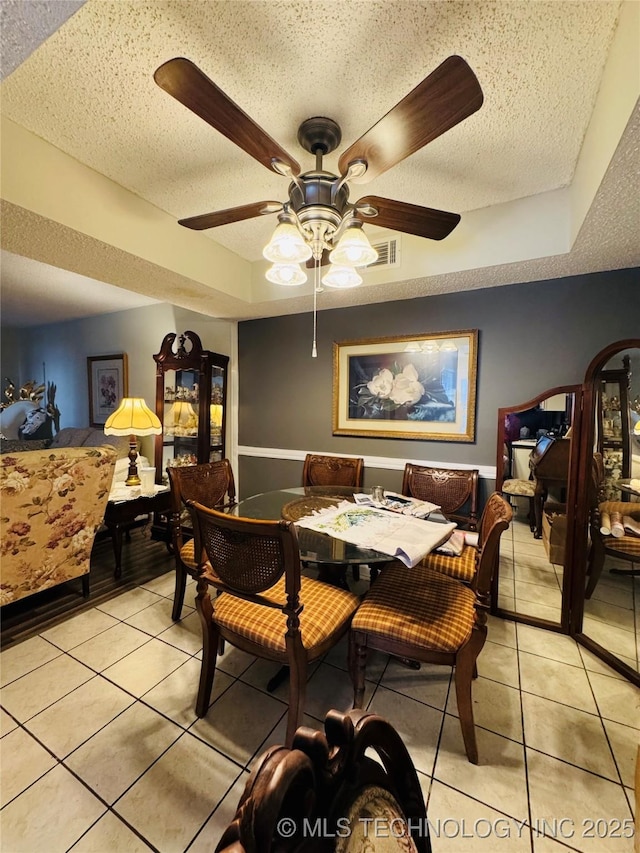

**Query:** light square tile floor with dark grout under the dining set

left=0, top=573, right=640, bottom=853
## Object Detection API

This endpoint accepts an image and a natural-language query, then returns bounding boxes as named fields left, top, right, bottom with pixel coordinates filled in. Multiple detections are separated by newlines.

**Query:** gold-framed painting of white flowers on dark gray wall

left=333, top=329, right=478, bottom=441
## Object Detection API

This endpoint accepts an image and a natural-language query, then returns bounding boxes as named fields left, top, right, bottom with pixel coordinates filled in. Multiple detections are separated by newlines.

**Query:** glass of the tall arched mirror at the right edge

left=577, top=341, right=640, bottom=683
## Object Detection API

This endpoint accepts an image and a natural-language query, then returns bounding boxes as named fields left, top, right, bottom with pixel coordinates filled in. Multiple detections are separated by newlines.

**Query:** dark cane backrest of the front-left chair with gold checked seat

left=188, top=501, right=300, bottom=604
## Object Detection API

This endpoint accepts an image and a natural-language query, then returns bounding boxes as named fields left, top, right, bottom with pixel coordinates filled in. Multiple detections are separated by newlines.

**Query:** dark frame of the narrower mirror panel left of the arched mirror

left=490, top=385, right=582, bottom=634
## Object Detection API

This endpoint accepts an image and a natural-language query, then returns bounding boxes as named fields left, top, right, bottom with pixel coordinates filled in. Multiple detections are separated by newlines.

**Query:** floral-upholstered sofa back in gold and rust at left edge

left=0, top=446, right=117, bottom=605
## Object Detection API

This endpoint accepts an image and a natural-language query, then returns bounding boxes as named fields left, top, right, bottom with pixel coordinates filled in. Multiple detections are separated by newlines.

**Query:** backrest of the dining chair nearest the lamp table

left=167, top=459, right=236, bottom=513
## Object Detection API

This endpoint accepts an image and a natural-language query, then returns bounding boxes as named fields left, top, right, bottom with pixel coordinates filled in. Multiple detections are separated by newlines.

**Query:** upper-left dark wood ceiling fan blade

left=158, top=57, right=300, bottom=175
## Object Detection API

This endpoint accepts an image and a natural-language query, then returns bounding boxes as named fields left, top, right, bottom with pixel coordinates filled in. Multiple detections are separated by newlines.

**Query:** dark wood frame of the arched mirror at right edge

left=565, top=338, right=640, bottom=687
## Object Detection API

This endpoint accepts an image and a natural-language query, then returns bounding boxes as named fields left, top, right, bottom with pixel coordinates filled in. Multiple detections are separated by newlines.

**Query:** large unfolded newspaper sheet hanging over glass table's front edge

left=296, top=501, right=456, bottom=566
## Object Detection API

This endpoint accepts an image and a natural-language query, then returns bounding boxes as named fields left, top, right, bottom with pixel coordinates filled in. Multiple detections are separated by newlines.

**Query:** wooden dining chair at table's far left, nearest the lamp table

left=167, top=459, right=236, bottom=622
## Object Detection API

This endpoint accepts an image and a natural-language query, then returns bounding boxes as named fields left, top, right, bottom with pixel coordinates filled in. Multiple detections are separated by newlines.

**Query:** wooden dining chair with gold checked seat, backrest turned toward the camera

left=189, top=502, right=360, bottom=746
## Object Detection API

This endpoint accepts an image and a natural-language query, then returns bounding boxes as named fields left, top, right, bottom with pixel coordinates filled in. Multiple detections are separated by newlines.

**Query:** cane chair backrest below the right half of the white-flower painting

left=402, top=462, right=479, bottom=530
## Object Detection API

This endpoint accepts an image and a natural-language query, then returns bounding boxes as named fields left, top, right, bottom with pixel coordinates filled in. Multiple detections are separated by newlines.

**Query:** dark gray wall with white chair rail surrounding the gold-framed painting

left=238, top=269, right=640, bottom=497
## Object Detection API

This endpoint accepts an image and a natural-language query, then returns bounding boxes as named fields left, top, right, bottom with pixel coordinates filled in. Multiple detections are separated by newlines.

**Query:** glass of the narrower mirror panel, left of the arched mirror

left=492, top=386, right=578, bottom=630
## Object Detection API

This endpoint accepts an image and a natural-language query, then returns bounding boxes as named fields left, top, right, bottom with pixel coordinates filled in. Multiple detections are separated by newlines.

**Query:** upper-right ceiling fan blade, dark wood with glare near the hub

left=338, top=56, right=483, bottom=184
